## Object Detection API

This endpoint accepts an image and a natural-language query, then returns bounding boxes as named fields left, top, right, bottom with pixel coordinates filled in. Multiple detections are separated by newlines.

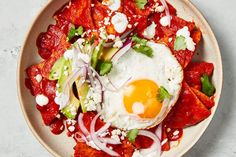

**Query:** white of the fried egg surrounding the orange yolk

left=102, top=42, right=183, bottom=130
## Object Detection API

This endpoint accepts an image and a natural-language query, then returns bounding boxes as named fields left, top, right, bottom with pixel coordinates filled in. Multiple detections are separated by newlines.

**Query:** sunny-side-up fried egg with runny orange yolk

left=102, top=42, right=183, bottom=130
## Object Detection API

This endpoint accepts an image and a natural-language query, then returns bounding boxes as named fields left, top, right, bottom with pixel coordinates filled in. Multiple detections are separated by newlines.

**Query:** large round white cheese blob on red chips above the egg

left=111, top=12, right=129, bottom=33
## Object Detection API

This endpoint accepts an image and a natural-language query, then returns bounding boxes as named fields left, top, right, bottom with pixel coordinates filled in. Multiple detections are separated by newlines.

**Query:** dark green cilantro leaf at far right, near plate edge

left=201, top=74, right=215, bottom=97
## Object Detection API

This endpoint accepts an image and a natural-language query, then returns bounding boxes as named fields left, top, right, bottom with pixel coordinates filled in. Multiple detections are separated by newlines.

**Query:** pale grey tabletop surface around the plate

left=0, top=0, right=236, bottom=157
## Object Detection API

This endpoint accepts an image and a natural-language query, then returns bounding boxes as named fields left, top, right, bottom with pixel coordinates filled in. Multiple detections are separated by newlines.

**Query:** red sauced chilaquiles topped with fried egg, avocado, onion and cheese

left=25, top=0, right=216, bottom=157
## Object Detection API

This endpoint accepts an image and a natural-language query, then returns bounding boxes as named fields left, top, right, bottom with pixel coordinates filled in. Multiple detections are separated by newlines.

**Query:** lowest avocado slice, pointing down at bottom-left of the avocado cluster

left=61, top=89, right=80, bottom=119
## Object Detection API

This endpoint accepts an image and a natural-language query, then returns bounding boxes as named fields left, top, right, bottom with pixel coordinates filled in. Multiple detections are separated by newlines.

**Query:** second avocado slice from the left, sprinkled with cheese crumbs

left=57, top=60, right=72, bottom=93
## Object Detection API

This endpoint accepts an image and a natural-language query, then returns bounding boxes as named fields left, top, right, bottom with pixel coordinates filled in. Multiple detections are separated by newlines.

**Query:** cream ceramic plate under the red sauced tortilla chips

left=17, top=0, right=223, bottom=157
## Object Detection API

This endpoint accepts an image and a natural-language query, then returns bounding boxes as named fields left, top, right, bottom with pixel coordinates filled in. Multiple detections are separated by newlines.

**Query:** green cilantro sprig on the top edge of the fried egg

left=131, top=35, right=153, bottom=57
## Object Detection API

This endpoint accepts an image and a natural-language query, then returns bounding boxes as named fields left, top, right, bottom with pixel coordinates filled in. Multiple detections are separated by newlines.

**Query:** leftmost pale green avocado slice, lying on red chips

left=49, top=57, right=66, bottom=80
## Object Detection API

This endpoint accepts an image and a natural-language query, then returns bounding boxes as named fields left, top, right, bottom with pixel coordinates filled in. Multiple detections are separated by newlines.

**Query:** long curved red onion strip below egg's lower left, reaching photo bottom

left=90, top=112, right=120, bottom=156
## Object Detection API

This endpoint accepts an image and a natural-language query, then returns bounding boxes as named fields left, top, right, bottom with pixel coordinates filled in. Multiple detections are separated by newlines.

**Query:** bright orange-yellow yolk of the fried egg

left=123, top=80, right=162, bottom=118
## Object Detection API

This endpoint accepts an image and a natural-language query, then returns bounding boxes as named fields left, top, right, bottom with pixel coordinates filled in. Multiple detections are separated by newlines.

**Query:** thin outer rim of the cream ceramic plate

left=16, top=0, right=224, bottom=157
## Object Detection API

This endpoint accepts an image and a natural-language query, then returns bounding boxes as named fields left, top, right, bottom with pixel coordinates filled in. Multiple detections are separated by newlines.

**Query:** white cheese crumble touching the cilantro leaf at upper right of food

left=176, top=26, right=196, bottom=51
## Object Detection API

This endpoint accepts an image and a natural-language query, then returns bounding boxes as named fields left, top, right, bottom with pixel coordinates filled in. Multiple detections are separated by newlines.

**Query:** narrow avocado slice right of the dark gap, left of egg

left=76, top=81, right=89, bottom=113
